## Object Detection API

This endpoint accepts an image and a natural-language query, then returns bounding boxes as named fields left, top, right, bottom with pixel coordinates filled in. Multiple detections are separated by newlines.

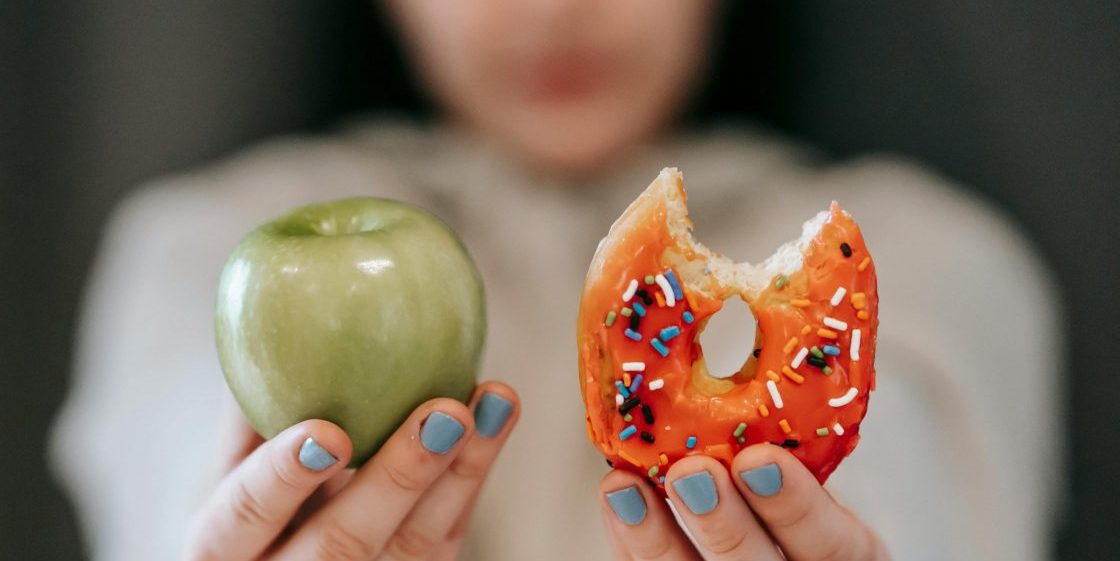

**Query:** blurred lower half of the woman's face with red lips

left=389, top=0, right=713, bottom=171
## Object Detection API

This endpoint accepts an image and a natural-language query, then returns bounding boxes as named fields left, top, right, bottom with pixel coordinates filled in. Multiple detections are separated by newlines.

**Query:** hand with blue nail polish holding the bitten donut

left=599, top=445, right=889, bottom=561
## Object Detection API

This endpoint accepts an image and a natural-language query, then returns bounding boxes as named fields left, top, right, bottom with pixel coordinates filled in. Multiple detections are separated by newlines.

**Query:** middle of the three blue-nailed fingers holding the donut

left=665, top=456, right=782, bottom=561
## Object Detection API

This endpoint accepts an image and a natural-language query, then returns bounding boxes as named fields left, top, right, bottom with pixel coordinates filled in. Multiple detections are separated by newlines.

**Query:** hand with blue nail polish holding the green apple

left=186, top=382, right=520, bottom=561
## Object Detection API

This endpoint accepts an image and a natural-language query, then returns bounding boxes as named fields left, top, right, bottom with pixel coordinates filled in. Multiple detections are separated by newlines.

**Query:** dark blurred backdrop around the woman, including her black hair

left=0, top=0, right=1120, bottom=559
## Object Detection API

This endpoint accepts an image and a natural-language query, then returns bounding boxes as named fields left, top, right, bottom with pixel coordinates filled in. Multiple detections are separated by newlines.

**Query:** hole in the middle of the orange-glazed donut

left=700, top=296, right=758, bottom=380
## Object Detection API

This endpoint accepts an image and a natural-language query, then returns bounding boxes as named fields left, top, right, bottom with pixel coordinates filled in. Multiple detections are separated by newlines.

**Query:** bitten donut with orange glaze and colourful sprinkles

left=577, top=168, right=878, bottom=485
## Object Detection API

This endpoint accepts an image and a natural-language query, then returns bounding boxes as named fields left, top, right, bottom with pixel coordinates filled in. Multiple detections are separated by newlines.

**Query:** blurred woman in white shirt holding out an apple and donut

left=54, top=0, right=1061, bottom=561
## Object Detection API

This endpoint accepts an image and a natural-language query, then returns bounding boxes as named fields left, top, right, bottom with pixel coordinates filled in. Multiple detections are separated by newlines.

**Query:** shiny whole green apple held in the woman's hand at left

left=215, top=197, right=486, bottom=466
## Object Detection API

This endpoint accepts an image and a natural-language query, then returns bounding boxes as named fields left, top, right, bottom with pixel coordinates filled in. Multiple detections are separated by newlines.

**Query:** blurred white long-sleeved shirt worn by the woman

left=52, top=122, right=1064, bottom=561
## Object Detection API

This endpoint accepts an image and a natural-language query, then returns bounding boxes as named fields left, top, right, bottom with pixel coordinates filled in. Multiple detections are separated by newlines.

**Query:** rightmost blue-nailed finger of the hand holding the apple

left=382, top=382, right=520, bottom=561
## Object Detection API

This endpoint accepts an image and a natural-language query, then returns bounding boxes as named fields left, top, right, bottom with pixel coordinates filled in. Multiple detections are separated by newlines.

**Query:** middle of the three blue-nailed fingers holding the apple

left=277, top=398, right=475, bottom=561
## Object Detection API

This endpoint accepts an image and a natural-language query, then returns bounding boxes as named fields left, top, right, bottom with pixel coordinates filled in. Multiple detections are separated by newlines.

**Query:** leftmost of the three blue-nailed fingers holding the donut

left=599, top=469, right=700, bottom=561
